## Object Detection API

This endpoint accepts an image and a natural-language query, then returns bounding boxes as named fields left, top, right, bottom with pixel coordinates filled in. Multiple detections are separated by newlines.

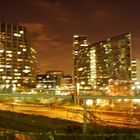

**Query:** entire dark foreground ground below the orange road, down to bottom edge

left=0, top=111, right=140, bottom=140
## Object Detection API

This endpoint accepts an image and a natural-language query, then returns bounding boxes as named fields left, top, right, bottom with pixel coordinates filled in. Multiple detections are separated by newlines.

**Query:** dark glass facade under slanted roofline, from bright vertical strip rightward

left=90, top=33, right=131, bottom=92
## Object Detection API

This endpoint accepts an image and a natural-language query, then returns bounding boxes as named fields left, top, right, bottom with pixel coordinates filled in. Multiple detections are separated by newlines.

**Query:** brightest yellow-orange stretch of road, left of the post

left=0, top=103, right=83, bottom=123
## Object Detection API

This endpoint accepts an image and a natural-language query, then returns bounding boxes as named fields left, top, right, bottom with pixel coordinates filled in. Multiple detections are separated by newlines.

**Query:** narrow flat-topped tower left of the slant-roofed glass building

left=73, top=35, right=89, bottom=93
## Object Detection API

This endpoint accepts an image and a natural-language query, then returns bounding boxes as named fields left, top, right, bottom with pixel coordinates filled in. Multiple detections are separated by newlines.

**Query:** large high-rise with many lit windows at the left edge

left=0, top=23, right=36, bottom=90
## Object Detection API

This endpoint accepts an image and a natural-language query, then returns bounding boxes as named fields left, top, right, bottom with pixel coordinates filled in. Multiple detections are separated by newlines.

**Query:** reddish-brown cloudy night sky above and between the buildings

left=0, top=0, right=140, bottom=74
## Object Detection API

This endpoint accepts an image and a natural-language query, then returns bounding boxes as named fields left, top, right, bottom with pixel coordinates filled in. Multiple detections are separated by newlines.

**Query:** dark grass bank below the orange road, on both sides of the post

left=0, top=111, right=140, bottom=134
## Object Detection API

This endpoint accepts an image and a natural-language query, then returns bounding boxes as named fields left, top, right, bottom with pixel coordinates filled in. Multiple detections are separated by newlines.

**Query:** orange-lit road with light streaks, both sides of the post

left=0, top=103, right=140, bottom=129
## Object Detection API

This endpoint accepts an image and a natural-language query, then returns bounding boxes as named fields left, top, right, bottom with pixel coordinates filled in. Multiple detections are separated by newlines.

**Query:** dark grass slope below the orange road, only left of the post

left=0, top=111, right=82, bottom=132
